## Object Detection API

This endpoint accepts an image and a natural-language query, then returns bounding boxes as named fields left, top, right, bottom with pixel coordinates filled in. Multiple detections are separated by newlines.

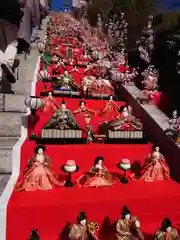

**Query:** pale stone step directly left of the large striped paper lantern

left=0, top=93, right=27, bottom=113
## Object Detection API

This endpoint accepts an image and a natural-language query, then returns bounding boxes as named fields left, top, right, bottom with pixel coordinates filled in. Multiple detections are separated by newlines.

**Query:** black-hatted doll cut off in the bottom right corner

left=154, top=218, right=180, bottom=240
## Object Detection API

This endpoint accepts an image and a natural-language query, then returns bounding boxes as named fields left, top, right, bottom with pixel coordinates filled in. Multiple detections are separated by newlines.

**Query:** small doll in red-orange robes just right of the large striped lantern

left=42, top=92, right=59, bottom=113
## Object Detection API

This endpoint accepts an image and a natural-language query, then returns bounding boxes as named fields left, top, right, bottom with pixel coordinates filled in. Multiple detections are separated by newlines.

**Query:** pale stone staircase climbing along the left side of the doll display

left=0, top=19, right=47, bottom=195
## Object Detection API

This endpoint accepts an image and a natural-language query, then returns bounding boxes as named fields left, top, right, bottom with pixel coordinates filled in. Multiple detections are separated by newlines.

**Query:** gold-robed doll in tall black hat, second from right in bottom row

left=116, top=206, right=144, bottom=240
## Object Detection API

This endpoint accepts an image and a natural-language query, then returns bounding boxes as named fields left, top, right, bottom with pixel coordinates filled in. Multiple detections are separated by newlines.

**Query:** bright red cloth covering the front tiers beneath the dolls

left=6, top=51, right=180, bottom=240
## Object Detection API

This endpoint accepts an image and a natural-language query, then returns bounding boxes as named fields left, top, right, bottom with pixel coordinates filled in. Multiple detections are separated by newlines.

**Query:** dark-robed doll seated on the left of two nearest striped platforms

left=44, top=100, right=80, bottom=130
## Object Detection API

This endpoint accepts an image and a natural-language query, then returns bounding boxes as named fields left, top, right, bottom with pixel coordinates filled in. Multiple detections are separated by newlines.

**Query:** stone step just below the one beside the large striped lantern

left=0, top=112, right=24, bottom=137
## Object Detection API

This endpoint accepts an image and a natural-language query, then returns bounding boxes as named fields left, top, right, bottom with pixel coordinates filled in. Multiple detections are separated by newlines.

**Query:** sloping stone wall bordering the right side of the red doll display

left=119, top=86, right=180, bottom=181
